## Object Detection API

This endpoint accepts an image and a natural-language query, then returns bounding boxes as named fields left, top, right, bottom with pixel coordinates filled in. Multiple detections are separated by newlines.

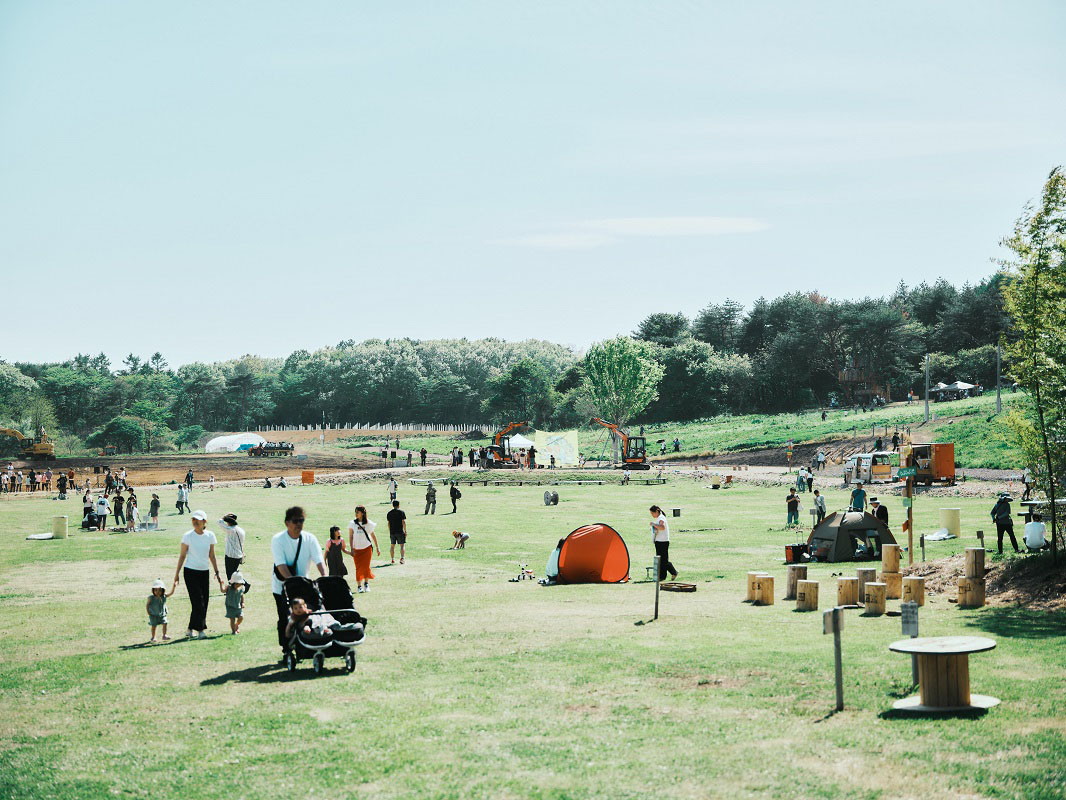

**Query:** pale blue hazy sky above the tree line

left=0, top=0, right=1066, bottom=366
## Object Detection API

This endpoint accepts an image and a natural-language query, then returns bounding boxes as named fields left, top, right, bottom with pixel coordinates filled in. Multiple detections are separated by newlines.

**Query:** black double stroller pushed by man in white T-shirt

left=285, top=577, right=367, bottom=674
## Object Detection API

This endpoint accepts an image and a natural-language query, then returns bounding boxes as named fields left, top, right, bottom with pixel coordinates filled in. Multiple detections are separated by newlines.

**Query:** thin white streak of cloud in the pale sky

left=497, top=217, right=770, bottom=250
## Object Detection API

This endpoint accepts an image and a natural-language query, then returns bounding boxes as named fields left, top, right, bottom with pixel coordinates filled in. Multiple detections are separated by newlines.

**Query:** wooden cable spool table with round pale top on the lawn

left=888, top=636, right=999, bottom=714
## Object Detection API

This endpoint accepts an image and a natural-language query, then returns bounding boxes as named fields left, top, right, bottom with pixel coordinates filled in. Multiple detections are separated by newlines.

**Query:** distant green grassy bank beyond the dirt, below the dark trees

left=332, top=394, right=1021, bottom=469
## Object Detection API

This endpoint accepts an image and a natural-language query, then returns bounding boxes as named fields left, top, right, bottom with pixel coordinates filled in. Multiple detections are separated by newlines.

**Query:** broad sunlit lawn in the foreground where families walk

left=0, top=482, right=1066, bottom=800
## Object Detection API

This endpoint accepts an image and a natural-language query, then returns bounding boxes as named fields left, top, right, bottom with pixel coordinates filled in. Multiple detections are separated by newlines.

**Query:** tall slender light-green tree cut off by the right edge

left=1004, top=166, right=1066, bottom=563
